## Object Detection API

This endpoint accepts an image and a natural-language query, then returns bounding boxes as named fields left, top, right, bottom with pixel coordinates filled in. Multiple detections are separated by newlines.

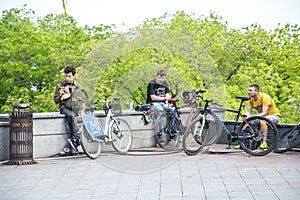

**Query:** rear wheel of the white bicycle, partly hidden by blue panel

left=80, top=128, right=101, bottom=159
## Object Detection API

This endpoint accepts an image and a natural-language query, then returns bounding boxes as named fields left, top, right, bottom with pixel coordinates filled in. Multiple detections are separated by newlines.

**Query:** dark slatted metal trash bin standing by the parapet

left=7, top=103, right=36, bottom=165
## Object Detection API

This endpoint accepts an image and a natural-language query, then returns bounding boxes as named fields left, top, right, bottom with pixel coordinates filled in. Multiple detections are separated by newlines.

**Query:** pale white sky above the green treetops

left=0, top=0, right=300, bottom=30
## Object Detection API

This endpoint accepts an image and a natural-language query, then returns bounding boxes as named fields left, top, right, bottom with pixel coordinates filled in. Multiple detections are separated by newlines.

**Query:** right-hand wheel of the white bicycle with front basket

left=110, top=118, right=132, bottom=154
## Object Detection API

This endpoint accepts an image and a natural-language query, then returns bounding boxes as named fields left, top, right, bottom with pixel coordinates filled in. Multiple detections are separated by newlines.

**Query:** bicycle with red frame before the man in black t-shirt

left=153, top=90, right=205, bottom=151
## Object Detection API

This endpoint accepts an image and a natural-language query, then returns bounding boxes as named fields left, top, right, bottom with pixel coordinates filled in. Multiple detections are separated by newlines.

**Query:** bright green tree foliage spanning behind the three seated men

left=0, top=6, right=300, bottom=123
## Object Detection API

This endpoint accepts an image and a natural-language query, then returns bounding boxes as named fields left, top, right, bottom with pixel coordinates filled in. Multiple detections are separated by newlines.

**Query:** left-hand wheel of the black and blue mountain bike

left=182, top=117, right=209, bottom=156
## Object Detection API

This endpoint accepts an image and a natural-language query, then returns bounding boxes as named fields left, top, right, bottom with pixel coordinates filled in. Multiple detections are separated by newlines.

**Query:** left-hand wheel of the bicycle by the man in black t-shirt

left=153, top=113, right=180, bottom=151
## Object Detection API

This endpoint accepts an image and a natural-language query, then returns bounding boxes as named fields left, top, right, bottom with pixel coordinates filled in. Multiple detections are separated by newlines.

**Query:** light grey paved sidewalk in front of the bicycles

left=0, top=146, right=300, bottom=200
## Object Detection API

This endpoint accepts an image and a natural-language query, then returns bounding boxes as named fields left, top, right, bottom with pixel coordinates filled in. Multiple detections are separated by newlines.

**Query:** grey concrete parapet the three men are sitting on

left=0, top=109, right=294, bottom=161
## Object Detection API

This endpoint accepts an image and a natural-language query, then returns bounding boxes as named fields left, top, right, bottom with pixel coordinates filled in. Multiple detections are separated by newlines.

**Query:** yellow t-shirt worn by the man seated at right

left=249, top=92, right=280, bottom=116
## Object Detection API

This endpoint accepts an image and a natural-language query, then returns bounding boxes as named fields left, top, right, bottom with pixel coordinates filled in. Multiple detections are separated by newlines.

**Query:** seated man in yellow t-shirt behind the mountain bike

left=245, top=84, right=280, bottom=149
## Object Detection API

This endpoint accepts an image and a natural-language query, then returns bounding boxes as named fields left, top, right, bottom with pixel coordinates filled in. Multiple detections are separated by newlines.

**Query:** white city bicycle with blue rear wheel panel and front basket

left=76, top=98, right=132, bottom=159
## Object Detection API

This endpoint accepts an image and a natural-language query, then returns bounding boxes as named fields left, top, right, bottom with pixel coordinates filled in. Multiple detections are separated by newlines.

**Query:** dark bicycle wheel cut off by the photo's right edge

left=274, top=123, right=300, bottom=153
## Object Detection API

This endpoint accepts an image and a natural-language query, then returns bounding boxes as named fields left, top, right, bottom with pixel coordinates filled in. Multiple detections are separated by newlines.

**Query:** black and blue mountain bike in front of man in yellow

left=182, top=91, right=278, bottom=156
